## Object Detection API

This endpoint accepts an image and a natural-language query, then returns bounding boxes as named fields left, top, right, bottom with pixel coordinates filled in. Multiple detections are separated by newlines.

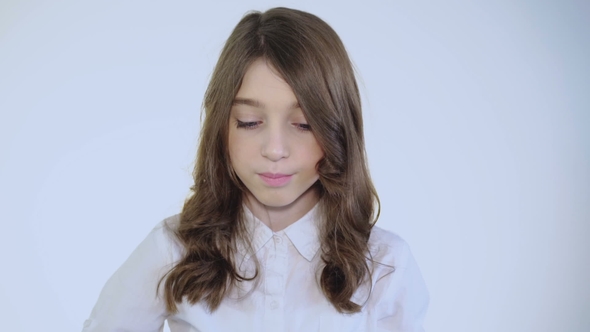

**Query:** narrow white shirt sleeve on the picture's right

left=377, top=240, right=429, bottom=332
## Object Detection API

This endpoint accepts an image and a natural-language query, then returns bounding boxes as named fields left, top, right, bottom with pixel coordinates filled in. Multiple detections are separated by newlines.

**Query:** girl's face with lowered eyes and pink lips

left=228, top=58, right=324, bottom=222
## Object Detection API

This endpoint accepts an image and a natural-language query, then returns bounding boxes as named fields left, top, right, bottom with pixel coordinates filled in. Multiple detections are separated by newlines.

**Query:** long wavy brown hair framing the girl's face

left=161, top=8, right=379, bottom=313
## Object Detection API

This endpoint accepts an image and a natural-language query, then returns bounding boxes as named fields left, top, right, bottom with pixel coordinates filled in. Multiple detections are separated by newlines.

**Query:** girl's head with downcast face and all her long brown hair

left=164, top=8, right=378, bottom=312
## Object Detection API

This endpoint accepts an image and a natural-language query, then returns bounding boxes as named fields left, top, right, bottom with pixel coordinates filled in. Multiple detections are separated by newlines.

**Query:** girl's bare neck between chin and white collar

left=245, top=186, right=319, bottom=232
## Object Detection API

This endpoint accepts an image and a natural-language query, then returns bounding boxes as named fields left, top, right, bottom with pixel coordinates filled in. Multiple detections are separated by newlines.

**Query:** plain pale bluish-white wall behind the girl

left=0, top=0, right=590, bottom=332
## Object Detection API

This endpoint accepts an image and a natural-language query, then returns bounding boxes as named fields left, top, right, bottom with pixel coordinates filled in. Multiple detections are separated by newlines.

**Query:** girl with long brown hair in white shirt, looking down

left=84, top=8, right=428, bottom=332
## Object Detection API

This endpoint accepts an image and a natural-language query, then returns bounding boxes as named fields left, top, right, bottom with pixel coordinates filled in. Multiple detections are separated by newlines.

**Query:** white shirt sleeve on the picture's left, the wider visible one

left=82, top=220, right=178, bottom=332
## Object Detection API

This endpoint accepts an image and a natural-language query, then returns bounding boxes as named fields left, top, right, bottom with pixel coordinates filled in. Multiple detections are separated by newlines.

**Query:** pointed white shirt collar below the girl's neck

left=239, top=204, right=320, bottom=261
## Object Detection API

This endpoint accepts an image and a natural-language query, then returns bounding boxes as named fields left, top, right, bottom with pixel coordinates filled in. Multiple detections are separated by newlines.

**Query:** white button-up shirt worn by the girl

left=83, top=208, right=429, bottom=332
